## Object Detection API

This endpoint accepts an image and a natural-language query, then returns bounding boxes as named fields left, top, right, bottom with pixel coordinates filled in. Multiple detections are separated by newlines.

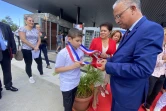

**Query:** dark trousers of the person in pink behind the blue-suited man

left=145, top=75, right=165, bottom=109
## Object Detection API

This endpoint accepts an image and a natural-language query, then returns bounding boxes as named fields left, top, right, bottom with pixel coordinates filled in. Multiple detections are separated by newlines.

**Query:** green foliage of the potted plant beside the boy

left=76, top=65, right=103, bottom=98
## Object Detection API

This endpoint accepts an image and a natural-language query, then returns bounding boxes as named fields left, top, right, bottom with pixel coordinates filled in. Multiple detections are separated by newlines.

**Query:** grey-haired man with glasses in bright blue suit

left=98, top=0, right=164, bottom=111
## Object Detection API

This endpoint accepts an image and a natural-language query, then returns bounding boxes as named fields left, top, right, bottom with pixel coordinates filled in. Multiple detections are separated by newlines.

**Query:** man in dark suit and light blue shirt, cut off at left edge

left=0, top=22, right=18, bottom=98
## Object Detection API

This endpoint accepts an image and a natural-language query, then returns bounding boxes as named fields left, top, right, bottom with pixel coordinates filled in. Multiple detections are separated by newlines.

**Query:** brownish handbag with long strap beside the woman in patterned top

left=15, top=36, right=23, bottom=61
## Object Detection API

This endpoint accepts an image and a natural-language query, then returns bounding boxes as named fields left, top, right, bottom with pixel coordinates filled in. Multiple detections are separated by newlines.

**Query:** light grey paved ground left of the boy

left=0, top=53, right=63, bottom=111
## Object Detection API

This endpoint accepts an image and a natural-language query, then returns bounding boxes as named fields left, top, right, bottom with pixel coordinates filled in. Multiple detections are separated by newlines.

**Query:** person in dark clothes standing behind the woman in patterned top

left=36, top=24, right=51, bottom=69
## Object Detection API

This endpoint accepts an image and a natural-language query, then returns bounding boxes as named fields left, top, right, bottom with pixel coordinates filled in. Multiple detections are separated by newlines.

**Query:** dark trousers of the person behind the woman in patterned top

left=39, top=44, right=50, bottom=66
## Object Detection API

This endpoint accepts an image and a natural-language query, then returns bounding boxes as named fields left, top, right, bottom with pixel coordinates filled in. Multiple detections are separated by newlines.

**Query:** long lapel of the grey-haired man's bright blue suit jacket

left=114, top=17, right=146, bottom=55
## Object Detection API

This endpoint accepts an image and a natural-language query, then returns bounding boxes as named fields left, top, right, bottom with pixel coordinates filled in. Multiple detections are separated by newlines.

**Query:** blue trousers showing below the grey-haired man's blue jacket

left=110, top=97, right=138, bottom=111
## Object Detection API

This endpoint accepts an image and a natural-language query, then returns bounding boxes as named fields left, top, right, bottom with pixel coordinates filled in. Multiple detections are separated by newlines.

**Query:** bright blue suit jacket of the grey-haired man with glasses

left=105, top=17, right=164, bottom=109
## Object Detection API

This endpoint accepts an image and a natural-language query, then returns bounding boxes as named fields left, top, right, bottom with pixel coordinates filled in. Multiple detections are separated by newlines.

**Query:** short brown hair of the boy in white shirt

left=67, top=28, right=83, bottom=39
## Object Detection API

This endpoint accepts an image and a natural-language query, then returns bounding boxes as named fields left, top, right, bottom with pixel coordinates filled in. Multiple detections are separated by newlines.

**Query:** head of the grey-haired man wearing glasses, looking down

left=113, top=0, right=142, bottom=29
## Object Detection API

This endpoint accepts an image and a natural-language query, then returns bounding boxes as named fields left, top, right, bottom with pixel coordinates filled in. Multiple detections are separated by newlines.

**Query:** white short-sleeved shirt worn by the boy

left=55, top=48, right=84, bottom=91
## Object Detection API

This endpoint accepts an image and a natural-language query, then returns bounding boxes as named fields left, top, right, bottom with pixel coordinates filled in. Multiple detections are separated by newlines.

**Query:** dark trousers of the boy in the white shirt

left=62, top=87, right=77, bottom=111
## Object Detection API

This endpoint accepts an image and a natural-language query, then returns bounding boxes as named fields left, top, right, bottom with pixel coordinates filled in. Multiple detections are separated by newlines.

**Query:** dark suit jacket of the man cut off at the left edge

left=0, top=22, right=17, bottom=56
